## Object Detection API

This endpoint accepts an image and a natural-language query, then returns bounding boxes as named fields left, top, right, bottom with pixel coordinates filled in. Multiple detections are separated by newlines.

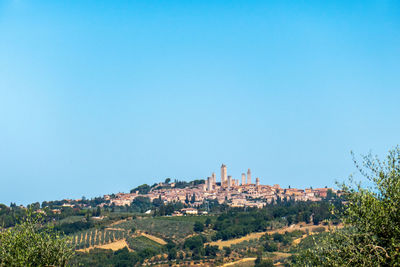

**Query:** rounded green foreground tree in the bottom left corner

left=0, top=212, right=73, bottom=266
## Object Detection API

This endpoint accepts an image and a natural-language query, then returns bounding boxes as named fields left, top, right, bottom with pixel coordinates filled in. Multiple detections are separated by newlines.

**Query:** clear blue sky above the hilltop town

left=0, top=0, right=400, bottom=204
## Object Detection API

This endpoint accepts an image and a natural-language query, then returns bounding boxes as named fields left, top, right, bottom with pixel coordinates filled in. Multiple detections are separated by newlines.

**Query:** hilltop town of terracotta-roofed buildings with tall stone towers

left=104, top=164, right=338, bottom=215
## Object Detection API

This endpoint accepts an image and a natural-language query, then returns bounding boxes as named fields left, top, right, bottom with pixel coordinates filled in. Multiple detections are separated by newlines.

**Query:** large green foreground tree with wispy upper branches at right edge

left=298, top=146, right=400, bottom=266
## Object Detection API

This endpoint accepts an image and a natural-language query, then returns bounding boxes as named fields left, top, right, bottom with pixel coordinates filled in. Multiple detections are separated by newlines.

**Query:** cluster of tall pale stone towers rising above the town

left=206, top=164, right=260, bottom=191
